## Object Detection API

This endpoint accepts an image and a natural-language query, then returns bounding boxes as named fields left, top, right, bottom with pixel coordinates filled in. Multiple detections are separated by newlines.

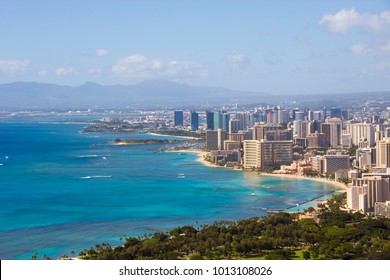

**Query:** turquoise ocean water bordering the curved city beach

left=0, top=117, right=335, bottom=259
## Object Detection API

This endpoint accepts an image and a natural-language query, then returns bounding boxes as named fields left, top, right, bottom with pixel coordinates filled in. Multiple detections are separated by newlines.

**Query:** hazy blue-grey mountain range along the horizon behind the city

left=0, top=80, right=390, bottom=109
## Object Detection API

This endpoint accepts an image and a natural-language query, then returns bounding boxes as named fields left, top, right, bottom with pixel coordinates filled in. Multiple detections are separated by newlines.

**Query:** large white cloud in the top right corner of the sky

left=319, top=8, right=390, bottom=33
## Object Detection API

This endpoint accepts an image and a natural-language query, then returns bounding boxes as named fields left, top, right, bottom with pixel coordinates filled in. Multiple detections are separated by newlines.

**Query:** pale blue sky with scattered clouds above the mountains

left=0, top=0, right=390, bottom=94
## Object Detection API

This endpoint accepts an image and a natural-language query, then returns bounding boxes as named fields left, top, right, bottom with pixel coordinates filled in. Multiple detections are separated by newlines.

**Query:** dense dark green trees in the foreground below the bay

left=79, top=194, right=390, bottom=260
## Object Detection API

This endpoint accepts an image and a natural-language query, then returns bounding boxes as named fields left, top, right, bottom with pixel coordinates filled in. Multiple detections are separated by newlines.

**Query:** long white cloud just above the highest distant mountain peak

left=111, top=54, right=208, bottom=78
